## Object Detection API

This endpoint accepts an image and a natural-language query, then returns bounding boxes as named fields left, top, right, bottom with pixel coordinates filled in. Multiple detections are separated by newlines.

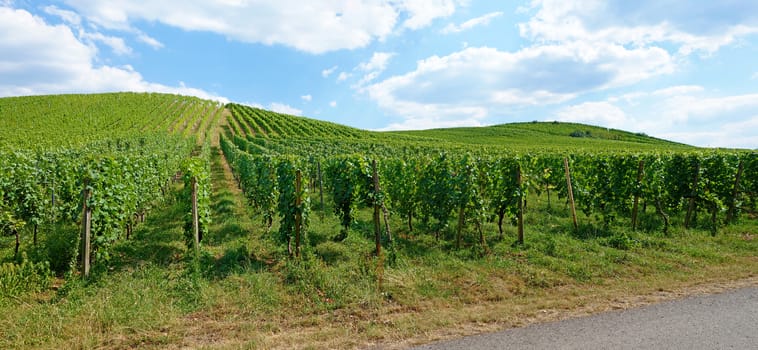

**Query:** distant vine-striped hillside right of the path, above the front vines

left=227, top=104, right=695, bottom=151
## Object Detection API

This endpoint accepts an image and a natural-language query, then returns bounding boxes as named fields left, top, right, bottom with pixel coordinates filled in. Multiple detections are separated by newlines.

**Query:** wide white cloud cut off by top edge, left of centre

left=58, top=0, right=466, bottom=54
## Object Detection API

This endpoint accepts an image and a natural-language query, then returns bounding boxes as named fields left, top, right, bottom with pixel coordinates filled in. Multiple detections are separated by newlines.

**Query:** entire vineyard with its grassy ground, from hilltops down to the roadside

left=0, top=93, right=758, bottom=348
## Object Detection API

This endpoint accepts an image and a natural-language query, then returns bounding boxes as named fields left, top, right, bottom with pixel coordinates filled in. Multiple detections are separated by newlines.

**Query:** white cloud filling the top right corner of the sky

left=519, top=0, right=758, bottom=55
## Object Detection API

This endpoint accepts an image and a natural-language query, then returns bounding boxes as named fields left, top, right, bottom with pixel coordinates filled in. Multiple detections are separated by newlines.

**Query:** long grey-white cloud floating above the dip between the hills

left=363, top=43, right=673, bottom=120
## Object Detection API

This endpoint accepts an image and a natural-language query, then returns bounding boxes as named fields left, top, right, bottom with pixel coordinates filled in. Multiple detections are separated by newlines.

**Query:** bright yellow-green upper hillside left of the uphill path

left=0, top=92, right=223, bottom=148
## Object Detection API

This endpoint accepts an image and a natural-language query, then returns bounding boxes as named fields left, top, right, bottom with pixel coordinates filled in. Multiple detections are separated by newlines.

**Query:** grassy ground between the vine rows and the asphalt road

left=0, top=146, right=758, bottom=349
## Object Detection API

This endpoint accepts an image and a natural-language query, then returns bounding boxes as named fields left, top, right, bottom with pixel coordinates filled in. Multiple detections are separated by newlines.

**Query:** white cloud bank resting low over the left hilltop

left=0, top=7, right=228, bottom=102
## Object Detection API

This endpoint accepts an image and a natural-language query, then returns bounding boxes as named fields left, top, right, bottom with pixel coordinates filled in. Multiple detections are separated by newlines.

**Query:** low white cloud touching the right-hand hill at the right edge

left=554, top=85, right=758, bottom=148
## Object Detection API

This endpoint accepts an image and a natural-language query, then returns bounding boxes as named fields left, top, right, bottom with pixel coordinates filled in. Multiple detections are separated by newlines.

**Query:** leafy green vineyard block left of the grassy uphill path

left=0, top=94, right=223, bottom=274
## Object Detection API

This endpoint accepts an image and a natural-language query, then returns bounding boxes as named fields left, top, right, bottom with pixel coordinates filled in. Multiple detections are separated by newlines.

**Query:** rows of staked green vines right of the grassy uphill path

left=221, top=105, right=758, bottom=254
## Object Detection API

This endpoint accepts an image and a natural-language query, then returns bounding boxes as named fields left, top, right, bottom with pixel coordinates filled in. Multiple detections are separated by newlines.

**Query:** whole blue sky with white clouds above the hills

left=0, top=0, right=758, bottom=149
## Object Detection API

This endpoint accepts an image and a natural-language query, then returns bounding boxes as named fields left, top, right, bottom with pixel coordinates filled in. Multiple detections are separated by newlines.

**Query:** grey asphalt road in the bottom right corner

left=415, top=287, right=758, bottom=350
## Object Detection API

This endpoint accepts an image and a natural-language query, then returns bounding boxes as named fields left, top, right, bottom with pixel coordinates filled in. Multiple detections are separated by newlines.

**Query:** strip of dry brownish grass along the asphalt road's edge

left=157, top=266, right=758, bottom=349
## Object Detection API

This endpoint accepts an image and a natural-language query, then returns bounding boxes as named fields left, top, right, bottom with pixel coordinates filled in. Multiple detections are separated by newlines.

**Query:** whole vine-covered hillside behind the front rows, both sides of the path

left=0, top=93, right=693, bottom=151
